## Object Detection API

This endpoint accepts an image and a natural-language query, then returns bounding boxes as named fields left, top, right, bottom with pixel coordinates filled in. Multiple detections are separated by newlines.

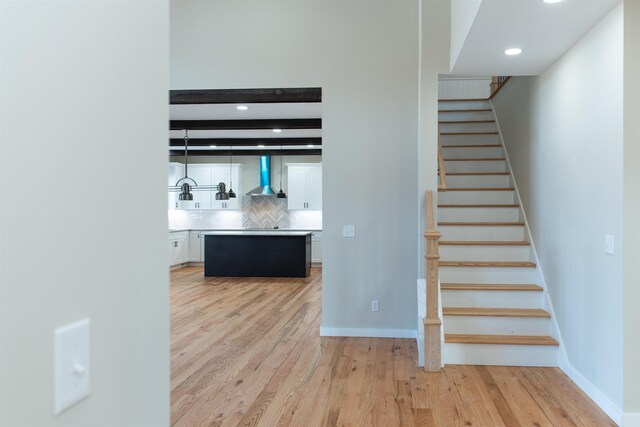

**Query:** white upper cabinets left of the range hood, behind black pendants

left=169, top=163, right=243, bottom=210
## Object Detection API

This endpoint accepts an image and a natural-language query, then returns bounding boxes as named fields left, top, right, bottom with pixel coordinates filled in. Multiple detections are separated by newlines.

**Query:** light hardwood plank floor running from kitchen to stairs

left=171, top=267, right=615, bottom=427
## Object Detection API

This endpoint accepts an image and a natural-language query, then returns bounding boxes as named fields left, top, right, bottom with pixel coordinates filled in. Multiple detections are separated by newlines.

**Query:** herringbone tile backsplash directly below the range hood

left=242, top=196, right=290, bottom=228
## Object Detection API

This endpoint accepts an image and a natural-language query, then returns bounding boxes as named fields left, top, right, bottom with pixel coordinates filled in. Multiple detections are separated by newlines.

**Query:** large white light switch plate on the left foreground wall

left=53, top=319, right=91, bottom=415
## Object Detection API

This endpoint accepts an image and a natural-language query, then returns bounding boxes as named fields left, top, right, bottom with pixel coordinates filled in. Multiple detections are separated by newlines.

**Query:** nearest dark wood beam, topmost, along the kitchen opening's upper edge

left=169, top=87, right=322, bottom=104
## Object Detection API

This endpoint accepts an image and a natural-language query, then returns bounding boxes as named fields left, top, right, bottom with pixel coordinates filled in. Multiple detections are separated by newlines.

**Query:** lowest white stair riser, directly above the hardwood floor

left=444, top=343, right=558, bottom=366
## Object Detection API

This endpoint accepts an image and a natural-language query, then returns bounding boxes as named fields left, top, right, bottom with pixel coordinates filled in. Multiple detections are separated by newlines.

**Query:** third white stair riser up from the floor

left=442, top=290, right=549, bottom=310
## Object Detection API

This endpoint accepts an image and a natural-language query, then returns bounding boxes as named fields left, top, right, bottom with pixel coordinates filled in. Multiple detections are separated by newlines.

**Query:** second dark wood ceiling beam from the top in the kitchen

left=169, top=119, right=322, bottom=130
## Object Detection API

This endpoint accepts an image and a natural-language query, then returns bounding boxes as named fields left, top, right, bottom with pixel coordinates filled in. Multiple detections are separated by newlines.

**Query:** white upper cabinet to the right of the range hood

left=287, top=163, right=322, bottom=210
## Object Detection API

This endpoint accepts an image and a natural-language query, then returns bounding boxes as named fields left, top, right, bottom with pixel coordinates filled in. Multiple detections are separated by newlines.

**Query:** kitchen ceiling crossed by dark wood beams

left=169, top=88, right=322, bottom=156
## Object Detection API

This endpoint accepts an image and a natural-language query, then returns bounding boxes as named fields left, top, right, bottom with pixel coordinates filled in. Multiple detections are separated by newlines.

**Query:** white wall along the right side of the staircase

left=494, top=3, right=623, bottom=416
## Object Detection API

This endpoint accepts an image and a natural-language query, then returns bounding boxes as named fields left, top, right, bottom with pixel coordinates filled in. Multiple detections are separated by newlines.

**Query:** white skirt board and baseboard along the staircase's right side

left=490, top=101, right=624, bottom=427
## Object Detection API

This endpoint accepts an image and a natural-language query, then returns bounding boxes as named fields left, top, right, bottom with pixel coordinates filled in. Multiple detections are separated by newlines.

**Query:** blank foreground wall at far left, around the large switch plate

left=0, top=1, right=169, bottom=427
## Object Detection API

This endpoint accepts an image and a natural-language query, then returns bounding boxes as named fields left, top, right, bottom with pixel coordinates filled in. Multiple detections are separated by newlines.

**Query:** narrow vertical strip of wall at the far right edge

left=623, top=1, right=640, bottom=427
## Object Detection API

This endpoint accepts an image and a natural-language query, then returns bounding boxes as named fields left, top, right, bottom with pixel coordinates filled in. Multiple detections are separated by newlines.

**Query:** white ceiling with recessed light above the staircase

left=450, top=0, right=620, bottom=76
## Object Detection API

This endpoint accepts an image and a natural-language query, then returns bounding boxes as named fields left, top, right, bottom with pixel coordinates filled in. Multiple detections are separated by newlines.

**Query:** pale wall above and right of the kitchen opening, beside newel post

left=171, top=0, right=419, bottom=331
